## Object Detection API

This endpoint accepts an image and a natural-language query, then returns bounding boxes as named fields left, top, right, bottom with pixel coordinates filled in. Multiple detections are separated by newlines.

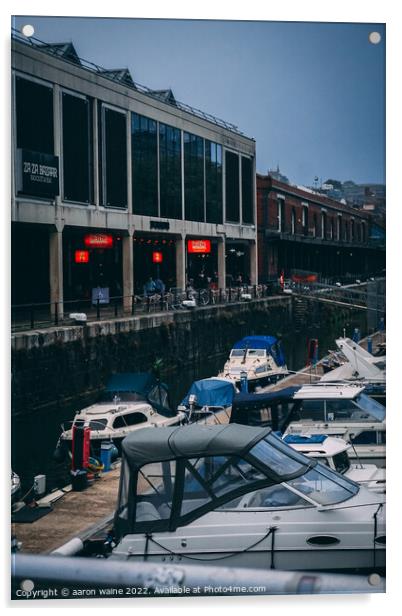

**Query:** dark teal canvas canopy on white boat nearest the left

left=104, top=372, right=175, bottom=417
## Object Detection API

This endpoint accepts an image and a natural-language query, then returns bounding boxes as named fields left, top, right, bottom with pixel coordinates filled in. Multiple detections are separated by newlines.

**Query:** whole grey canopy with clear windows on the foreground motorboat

left=114, top=424, right=317, bottom=537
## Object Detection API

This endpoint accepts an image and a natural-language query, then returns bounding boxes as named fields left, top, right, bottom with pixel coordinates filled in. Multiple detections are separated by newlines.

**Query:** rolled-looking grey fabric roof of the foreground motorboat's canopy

left=122, top=423, right=272, bottom=469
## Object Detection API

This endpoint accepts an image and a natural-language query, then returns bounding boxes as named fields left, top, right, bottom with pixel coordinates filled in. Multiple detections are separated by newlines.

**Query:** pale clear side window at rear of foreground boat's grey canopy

left=135, top=461, right=176, bottom=523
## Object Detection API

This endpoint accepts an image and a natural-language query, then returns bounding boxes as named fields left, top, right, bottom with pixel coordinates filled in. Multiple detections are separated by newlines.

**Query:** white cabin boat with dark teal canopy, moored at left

left=56, top=372, right=186, bottom=457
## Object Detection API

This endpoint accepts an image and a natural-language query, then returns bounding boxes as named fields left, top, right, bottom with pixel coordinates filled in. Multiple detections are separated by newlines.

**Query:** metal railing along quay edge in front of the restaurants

left=11, top=282, right=280, bottom=332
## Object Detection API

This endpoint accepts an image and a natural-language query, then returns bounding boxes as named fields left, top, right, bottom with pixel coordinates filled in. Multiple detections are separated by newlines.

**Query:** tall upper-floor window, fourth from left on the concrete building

left=131, top=113, right=158, bottom=216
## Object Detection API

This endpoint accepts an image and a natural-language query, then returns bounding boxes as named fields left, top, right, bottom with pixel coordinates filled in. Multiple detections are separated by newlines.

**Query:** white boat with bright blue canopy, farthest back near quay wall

left=219, top=336, right=289, bottom=389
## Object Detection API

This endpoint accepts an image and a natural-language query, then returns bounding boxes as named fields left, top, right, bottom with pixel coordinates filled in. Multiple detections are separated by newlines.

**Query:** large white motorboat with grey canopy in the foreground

left=110, top=424, right=385, bottom=572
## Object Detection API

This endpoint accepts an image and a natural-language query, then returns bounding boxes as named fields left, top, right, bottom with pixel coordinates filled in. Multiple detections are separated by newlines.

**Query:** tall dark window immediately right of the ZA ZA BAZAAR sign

left=62, top=93, right=93, bottom=203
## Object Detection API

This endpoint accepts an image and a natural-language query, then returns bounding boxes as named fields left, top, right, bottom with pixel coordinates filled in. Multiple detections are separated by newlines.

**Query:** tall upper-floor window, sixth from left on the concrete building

left=184, top=133, right=205, bottom=222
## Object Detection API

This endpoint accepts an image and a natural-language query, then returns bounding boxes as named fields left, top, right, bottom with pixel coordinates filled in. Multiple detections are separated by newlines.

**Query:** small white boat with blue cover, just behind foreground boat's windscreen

left=283, top=434, right=385, bottom=494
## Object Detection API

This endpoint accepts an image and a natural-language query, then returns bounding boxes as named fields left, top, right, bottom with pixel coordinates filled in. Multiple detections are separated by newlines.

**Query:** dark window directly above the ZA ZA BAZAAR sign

left=16, top=77, right=54, bottom=154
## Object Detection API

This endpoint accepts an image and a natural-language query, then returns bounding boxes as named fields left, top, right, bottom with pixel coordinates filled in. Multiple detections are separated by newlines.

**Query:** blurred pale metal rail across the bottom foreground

left=12, top=554, right=385, bottom=599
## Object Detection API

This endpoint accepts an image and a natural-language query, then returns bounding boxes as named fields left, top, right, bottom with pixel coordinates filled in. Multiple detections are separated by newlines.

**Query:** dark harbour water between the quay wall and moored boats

left=12, top=327, right=358, bottom=493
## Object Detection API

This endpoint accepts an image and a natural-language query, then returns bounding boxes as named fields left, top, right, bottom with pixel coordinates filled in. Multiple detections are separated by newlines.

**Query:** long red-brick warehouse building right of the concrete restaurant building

left=257, top=174, right=385, bottom=282
